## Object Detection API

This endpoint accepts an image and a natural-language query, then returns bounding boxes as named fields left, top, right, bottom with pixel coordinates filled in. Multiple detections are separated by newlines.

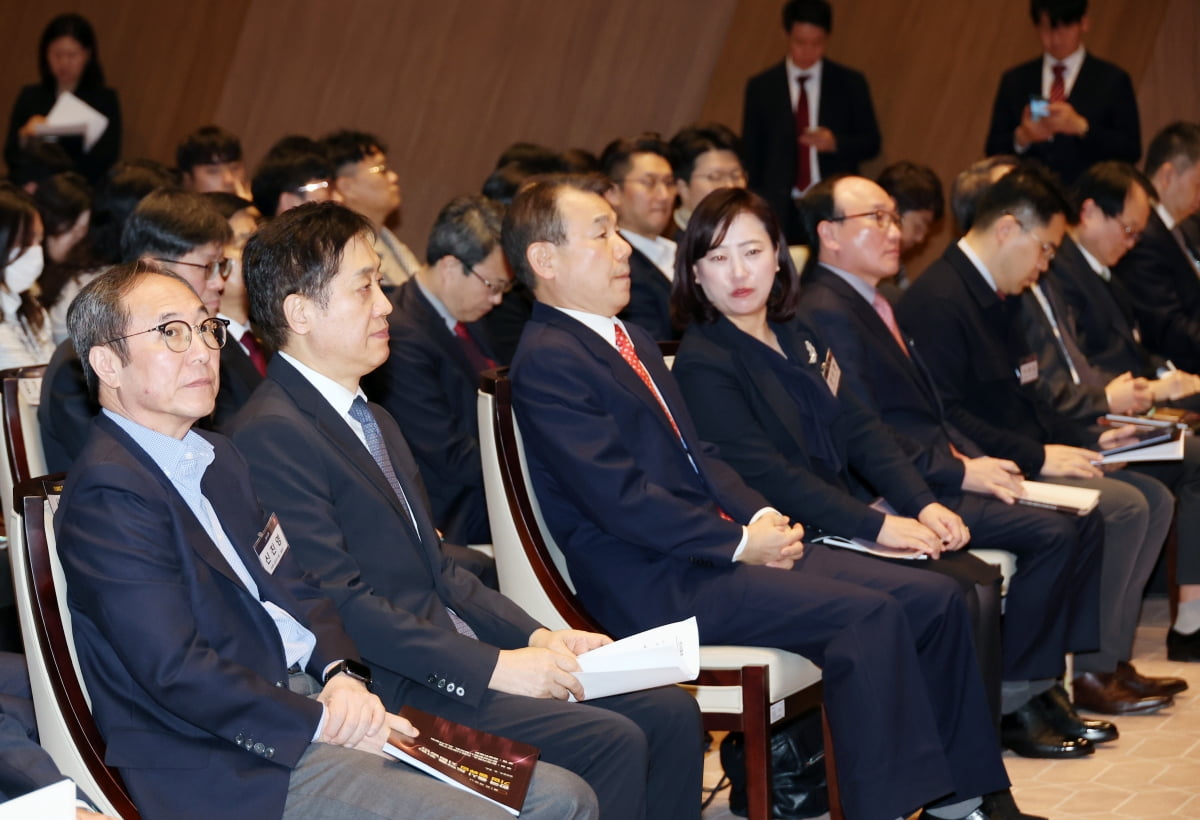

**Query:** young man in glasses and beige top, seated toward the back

left=320, top=130, right=421, bottom=285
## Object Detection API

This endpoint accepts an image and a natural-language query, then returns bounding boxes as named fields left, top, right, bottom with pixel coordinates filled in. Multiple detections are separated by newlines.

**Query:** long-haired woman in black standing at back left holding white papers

left=4, top=14, right=121, bottom=185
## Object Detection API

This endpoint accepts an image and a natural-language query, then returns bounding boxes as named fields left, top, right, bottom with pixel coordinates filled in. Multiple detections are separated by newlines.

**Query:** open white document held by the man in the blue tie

left=572, top=617, right=700, bottom=700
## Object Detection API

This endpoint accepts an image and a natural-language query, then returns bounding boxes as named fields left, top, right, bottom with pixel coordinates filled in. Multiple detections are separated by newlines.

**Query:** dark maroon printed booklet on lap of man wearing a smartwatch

left=383, top=706, right=538, bottom=815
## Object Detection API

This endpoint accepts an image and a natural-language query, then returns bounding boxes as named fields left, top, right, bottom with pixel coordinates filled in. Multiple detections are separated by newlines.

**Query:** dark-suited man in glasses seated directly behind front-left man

left=37, top=188, right=263, bottom=472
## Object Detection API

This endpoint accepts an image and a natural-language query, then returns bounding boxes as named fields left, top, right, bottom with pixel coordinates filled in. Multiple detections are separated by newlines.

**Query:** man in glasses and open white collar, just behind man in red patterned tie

left=600, top=133, right=680, bottom=341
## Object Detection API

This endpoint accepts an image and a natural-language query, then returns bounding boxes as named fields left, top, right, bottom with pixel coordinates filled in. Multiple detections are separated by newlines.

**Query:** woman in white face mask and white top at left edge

left=0, top=182, right=54, bottom=370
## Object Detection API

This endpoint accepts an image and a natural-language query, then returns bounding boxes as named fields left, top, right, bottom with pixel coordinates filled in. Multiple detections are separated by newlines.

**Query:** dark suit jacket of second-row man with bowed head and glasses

left=362, top=279, right=494, bottom=544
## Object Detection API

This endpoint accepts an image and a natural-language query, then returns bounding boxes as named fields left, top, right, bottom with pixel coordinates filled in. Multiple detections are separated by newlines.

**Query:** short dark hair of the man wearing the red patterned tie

left=500, top=174, right=612, bottom=291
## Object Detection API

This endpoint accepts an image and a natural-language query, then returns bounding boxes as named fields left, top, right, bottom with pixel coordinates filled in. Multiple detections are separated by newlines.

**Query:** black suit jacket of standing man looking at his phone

left=984, top=54, right=1141, bottom=185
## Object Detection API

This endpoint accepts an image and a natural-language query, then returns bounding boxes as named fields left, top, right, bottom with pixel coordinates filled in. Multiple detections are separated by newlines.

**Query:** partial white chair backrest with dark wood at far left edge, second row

left=0, top=365, right=46, bottom=521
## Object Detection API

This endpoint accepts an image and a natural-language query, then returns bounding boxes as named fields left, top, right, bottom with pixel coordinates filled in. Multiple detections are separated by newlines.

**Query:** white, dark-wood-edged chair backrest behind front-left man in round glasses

left=8, top=474, right=140, bottom=820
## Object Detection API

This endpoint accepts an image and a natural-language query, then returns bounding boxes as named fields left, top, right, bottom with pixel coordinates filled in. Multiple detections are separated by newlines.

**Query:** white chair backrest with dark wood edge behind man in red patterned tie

left=478, top=367, right=602, bottom=632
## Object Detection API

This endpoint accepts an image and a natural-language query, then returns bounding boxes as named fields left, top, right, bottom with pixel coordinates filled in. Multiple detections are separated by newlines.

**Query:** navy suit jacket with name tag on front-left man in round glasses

left=54, top=415, right=359, bottom=818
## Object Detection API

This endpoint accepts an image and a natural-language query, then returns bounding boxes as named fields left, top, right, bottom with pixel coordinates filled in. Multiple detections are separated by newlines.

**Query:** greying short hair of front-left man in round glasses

left=67, top=259, right=188, bottom=395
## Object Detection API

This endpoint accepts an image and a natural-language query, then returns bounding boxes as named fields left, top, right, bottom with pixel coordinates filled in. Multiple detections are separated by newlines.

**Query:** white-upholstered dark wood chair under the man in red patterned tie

left=478, top=370, right=841, bottom=820
